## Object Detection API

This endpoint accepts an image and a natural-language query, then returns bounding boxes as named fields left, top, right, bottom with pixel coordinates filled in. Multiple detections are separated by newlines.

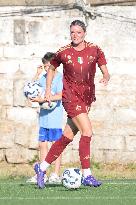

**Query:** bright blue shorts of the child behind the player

left=39, top=127, right=62, bottom=142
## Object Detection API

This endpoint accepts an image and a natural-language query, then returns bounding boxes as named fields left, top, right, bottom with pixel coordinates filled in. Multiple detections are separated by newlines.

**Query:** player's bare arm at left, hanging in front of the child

left=45, top=65, right=55, bottom=102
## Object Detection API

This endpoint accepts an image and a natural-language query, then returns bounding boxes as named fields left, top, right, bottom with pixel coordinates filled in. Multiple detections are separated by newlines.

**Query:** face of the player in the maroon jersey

left=70, top=25, right=86, bottom=45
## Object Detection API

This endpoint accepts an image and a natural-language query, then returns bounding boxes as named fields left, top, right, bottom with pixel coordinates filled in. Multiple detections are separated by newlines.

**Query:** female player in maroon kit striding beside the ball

left=35, top=20, right=110, bottom=188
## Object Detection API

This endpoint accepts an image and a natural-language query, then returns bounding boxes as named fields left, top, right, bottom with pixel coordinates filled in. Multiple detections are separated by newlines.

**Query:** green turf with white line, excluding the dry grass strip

left=0, top=178, right=136, bottom=205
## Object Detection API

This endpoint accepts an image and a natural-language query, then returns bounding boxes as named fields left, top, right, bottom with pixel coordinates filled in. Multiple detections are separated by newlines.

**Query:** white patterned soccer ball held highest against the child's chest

left=24, top=81, right=42, bottom=98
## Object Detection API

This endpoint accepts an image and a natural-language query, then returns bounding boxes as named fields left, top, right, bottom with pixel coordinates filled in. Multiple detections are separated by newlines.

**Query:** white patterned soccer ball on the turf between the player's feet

left=62, top=168, right=82, bottom=189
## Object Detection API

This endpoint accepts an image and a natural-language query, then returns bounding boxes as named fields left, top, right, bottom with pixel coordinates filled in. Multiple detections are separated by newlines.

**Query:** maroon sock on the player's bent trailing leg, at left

left=45, top=135, right=72, bottom=164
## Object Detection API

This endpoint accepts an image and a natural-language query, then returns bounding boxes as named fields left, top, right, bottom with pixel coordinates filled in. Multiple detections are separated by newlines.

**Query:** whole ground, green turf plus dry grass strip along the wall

left=0, top=163, right=136, bottom=205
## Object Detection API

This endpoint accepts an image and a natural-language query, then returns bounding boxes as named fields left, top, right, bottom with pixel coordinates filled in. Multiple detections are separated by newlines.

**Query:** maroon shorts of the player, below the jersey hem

left=63, top=101, right=91, bottom=118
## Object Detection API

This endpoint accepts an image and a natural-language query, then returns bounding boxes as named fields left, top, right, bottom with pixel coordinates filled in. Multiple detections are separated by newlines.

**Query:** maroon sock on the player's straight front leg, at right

left=79, top=135, right=91, bottom=169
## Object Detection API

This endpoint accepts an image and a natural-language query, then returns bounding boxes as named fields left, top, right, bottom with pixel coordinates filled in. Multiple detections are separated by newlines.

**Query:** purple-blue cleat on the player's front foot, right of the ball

left=82, top=175, right=102, bottom=187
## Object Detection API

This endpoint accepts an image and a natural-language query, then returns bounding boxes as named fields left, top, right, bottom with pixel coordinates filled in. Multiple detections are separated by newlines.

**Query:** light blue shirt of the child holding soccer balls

left=39, top=72, right=63, bottom=129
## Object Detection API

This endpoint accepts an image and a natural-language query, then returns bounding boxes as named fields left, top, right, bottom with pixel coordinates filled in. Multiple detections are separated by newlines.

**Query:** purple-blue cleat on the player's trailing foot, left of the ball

left=34, top=163, right=45, bottom=189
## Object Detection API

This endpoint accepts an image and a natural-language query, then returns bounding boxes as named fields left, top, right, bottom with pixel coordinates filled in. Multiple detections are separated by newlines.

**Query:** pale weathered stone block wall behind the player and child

left=0, top=5, right=136, bottom=163
